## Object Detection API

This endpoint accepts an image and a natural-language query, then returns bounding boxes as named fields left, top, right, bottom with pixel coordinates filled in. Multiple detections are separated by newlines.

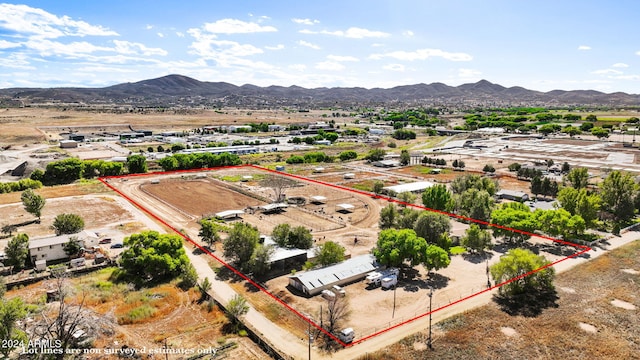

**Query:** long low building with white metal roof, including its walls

left=289, top=254, right=378, bottom=296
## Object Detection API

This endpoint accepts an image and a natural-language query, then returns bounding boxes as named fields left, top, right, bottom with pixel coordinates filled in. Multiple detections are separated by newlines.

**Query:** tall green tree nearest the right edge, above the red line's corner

left=600, top=170, right=637, bottom=222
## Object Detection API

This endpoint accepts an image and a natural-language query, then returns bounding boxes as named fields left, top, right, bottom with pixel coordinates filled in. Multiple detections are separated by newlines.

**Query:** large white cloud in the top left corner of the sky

left=0, top=4, right=118, bottom=39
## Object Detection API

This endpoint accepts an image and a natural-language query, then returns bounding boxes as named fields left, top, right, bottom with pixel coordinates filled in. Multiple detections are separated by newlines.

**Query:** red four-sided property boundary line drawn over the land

left=98, top=165, right=591, bottom=347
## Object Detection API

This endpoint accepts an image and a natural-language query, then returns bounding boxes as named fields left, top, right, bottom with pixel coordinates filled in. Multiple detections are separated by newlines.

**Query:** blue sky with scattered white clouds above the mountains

left=0, top=0, right=640, bottom=94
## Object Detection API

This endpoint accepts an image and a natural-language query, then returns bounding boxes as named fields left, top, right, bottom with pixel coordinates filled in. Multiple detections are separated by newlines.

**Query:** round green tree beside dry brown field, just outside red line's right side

left=490, top=248, right=555, bottom=296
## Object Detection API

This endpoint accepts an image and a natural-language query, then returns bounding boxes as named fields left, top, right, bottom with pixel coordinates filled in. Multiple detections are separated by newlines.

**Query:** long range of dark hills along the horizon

left=0, top=75, right=640, bottom=108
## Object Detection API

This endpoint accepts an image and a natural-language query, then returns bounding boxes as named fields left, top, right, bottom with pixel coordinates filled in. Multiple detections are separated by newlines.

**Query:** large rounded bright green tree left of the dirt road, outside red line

left=120, top=231, right=191, bottom=283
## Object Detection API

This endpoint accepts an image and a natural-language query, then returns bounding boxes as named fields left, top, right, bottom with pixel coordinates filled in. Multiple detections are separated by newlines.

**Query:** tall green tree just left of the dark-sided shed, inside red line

left=222, top=223, right=260, bottom=270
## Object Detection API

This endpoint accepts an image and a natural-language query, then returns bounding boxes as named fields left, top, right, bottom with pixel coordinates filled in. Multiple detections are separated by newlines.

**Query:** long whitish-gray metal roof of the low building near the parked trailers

left=289, top=254, right=377, bottom=291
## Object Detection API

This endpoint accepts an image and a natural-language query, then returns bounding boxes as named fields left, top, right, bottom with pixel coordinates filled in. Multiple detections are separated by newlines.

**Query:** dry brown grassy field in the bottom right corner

left=360, top=240, right=640, bottom=360
